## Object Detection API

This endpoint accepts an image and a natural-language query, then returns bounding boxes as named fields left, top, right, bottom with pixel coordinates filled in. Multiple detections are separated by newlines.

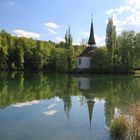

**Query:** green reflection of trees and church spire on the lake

left=0, top=72, right=140, bottom=126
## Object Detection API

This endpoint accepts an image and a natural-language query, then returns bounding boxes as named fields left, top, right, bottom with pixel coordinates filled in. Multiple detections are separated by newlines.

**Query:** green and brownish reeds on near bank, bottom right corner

left=110, top=102, right=140, bottom=140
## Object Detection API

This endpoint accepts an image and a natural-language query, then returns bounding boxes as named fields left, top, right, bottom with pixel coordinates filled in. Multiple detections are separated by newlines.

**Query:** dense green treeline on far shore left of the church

left=0, top=29, right=83, bottom=72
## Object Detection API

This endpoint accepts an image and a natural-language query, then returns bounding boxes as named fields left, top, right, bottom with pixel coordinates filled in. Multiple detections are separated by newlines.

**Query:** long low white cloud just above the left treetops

left=13, top=29, right=40, bottom=38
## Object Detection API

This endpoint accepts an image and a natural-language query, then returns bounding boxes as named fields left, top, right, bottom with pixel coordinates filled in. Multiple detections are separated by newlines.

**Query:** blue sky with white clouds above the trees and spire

left=0, top=0, right=140, bottom=46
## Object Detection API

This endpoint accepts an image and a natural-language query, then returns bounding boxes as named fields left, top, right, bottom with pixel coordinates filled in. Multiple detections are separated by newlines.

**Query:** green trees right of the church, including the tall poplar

left=92, top=18, right=140, bottom=73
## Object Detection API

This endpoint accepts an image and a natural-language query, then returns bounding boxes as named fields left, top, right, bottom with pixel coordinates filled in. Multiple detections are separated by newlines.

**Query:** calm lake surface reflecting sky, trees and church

left=0, top=73, right=140, bottom=140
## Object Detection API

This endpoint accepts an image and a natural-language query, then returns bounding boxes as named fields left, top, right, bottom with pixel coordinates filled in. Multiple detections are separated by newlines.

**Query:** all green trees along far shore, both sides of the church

left=0, top=18, right=140, bottom=73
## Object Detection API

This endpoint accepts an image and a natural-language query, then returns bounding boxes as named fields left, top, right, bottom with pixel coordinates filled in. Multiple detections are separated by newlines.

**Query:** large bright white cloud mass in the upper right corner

left=106, top=0, right=140, bottom=34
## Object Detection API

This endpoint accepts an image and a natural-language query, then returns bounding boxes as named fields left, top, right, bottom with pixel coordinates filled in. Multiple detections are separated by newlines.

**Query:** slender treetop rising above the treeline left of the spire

left=65, top=27, right=72, bottom=48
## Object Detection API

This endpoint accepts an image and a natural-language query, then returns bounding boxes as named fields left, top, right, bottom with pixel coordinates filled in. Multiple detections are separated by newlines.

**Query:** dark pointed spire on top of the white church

left=88, top=14, right=96, bottom=46
